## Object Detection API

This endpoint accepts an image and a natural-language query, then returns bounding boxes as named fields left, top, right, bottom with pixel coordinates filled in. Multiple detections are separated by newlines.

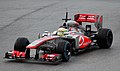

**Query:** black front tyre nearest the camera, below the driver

left=56, top=40, right=71, bottom=62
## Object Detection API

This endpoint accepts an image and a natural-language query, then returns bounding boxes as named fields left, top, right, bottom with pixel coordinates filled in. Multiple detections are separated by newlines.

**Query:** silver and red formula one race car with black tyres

left=4, top=12, right=113, bottom=63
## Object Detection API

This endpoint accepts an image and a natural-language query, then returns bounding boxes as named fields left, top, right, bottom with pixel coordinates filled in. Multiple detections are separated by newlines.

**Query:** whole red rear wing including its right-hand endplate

left=74, top=14, right=103, bottom=29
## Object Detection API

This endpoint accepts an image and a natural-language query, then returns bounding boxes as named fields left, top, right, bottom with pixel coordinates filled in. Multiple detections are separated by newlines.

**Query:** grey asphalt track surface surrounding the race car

left=0, top=0, right=120, bottom=71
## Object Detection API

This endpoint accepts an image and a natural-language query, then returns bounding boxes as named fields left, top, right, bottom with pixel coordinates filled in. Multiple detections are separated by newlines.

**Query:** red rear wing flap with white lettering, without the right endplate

left=74, top=14, right=99, bottom=23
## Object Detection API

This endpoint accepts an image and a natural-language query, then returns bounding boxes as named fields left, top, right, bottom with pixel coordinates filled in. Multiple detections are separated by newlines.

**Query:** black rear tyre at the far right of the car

left=97, top=28, right=113, bottom=49
